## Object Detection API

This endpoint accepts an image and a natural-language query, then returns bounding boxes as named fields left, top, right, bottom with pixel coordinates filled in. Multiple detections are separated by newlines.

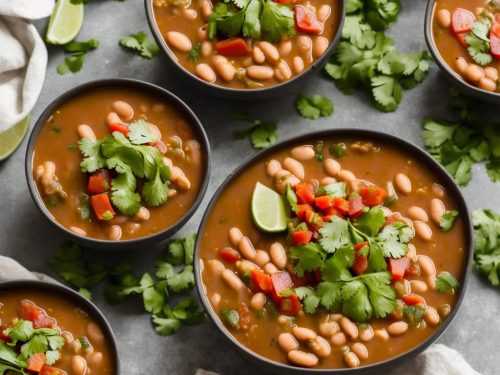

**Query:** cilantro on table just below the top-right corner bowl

left=422, top=90, right=500, bottom=186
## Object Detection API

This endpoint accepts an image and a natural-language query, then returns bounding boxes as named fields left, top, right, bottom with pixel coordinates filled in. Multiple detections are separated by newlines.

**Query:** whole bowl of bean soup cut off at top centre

left=145, top=0, right=345, bottom=99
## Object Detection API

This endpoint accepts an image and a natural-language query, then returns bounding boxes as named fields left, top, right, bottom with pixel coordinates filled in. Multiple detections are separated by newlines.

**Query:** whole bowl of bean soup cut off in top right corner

left=425, top=0, right=500, bottom=103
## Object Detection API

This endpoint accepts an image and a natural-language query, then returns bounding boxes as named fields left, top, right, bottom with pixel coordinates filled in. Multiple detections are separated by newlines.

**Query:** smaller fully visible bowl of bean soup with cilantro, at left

left=26, top=79, right=210, bottom=249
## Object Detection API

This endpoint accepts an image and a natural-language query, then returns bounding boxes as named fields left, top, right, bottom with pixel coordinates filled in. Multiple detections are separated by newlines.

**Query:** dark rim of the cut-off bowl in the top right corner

left=424, top=0, right=500, bottom=104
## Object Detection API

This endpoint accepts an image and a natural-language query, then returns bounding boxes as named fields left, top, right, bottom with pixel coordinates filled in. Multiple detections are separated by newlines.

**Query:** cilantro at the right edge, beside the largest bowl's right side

left=472, top=210, right=500, bottom=286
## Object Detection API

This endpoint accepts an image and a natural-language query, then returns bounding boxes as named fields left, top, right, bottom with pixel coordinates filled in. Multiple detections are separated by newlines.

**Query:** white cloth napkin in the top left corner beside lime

left=0, top=0, right=54, bottom=132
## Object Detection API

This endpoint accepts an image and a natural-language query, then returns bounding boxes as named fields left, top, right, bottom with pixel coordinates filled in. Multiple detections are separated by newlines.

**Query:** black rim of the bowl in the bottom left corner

left=0, top=279, right=120, bottom=374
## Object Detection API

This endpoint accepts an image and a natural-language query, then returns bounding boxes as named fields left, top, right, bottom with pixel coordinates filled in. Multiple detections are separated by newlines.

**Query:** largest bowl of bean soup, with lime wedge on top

left=195, top=129, right=472, bottom=374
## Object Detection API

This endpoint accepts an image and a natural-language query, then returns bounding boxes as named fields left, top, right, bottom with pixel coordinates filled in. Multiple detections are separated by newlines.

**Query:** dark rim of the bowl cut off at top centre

left=144, top=0, right=347, bottom=97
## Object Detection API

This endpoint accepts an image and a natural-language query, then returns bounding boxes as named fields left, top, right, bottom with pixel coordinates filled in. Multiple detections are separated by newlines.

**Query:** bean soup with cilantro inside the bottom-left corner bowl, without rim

left=0, top=290, right=117, bottom=375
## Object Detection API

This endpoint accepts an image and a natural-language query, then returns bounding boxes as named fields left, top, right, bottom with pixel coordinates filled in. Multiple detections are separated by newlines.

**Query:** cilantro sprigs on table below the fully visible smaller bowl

left=50, top=235, right=204, bottom=335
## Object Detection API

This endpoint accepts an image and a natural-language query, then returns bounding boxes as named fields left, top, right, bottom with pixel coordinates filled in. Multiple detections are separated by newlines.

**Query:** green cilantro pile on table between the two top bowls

left=325, top=0, right=430, bottom=112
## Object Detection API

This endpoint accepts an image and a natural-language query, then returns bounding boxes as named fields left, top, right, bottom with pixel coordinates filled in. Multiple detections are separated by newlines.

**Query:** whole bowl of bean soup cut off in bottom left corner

left=0, top=280, right=120, bottom=375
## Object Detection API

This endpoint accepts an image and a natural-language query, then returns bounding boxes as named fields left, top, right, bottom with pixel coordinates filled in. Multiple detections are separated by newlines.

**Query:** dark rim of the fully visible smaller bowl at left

left=25, top=78, right=212, bottom=250
